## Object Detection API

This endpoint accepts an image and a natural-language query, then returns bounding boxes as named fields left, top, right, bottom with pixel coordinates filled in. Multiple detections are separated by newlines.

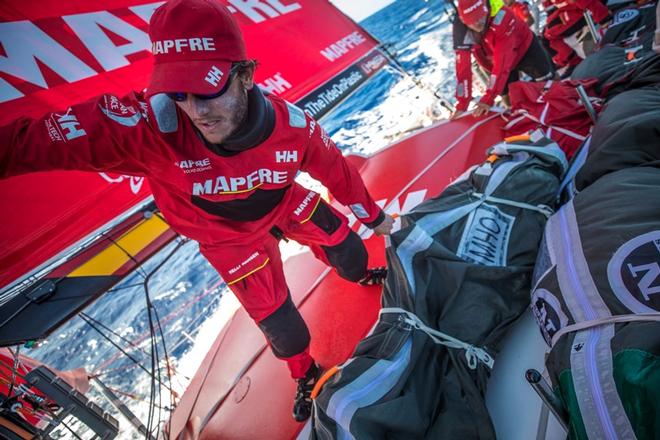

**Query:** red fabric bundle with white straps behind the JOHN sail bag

left=505, top=79, right=601, bottom=159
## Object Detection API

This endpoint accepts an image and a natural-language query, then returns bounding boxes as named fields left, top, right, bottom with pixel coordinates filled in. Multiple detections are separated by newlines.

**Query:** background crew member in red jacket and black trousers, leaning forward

left=452, top=0, right=555, bottom=119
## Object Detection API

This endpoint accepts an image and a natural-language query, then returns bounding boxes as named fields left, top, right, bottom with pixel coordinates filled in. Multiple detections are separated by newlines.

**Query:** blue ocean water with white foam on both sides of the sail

left=23, top=0, right=454, bottom=439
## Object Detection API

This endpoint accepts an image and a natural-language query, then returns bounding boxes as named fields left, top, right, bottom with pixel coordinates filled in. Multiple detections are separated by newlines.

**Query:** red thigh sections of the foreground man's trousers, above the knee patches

left=200, top=185, right=350, bottom=321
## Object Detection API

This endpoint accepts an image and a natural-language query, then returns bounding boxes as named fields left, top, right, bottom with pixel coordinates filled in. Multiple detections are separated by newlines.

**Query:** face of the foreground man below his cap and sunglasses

left=175, top=71, right=253, bottom=144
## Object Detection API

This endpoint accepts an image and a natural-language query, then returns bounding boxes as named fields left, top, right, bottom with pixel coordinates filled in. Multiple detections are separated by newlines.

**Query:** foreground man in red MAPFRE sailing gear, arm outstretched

left=0, top=0, right=393, bottom=421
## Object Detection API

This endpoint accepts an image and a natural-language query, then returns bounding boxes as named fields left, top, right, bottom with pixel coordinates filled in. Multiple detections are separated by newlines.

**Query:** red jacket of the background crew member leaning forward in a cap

left=453, top=6, right=533, bottom=111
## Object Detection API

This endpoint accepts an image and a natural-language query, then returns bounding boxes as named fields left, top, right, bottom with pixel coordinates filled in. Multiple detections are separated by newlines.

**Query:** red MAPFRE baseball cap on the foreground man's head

left=147, top=0, right=247, bottom=96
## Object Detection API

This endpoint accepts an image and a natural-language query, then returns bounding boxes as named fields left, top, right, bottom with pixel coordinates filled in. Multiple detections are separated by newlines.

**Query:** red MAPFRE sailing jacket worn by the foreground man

left=0, top=89, right=383, bottom=245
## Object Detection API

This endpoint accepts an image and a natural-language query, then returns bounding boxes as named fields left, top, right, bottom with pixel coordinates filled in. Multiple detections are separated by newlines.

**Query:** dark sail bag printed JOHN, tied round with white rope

left=311, top=138, right=567, bottom=440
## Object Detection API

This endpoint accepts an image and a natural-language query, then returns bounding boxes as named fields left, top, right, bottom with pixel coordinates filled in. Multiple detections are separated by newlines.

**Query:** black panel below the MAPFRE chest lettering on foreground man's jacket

left=190, top=185, right=290, bottom=222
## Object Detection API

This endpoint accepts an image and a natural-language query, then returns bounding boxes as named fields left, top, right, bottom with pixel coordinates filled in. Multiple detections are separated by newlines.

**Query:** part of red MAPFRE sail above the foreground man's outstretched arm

left=0, top=0, right=378, bottom=124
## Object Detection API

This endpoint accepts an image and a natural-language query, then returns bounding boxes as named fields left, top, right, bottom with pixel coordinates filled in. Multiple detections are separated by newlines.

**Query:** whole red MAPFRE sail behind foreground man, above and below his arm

left=0, top=0, right=378, bottom=286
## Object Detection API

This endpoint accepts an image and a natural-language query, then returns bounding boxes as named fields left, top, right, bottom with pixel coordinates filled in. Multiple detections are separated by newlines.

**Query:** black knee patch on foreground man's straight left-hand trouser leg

left=258, top=293, right=310, bottom=358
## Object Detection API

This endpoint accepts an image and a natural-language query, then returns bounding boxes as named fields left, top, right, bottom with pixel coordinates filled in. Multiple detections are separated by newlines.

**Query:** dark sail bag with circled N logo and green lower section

left=532, top=167, right=660, bottom=440
